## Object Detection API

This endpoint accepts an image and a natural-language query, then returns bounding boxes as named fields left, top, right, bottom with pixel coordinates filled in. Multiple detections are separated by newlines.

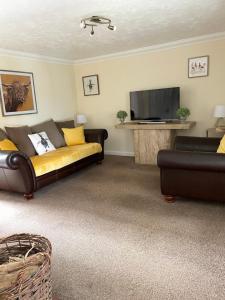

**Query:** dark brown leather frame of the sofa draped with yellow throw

left=0, top=121, right=108, bottom=199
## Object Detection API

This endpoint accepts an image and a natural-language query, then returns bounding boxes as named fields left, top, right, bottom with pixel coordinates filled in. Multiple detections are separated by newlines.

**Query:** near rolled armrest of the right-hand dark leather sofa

left=157, top=150, right=225, bottom=172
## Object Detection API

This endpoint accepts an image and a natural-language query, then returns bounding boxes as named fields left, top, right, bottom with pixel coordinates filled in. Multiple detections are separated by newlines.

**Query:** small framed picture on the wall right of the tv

left=188, top=55, right=209, bottom=78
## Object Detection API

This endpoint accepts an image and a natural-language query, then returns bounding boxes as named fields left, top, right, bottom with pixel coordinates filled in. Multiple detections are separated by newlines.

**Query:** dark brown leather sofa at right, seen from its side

left=158, top=136, right=225, bottom=202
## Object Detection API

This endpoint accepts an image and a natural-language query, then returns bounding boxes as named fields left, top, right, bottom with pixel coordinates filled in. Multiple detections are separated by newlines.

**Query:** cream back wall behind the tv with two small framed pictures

left=74, top=39, right=225, bottom=154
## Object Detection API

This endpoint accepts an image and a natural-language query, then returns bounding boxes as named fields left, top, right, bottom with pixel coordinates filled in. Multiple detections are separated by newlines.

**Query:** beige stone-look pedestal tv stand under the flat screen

left=116, top=122, right=196, bottom=165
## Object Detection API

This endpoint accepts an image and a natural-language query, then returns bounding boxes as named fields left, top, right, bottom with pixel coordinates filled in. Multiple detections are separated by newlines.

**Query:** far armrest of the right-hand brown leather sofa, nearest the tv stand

left=174, top=136, right=220, bottom=152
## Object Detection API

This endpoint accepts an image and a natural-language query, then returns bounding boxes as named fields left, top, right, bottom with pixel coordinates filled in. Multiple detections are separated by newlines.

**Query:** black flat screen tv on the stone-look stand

left=130, top=87, right=180, bottom=121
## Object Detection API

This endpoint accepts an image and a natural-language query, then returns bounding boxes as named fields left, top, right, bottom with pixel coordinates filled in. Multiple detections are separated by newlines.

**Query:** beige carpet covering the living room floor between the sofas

left=0, top=156, right=225, bottom=300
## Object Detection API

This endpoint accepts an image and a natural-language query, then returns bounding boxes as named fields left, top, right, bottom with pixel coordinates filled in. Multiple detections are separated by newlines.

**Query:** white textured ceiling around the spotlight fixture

left=0, top=0, right=225, bottom=60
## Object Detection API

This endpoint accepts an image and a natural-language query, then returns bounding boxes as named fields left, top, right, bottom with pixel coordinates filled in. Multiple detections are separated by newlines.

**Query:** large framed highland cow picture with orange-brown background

left=0, top=70, right=37, bottom=116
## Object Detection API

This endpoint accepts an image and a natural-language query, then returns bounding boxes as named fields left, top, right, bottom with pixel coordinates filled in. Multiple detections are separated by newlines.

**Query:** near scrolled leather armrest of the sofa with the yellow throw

left=0, top=151, right=36, bottom=195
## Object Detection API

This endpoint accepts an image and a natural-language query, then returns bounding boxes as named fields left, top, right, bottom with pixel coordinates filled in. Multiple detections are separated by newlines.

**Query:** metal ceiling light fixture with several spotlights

left=80, top=16, right=116, bottom=36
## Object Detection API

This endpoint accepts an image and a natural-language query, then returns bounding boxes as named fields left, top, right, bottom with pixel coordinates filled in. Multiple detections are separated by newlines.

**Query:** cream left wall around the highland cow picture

left=0, top=56, right=75, bottom=128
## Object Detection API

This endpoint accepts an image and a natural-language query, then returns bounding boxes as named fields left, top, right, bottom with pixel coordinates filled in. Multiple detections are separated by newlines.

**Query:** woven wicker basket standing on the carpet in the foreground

left=0, top=233, right=52, bottom=300
